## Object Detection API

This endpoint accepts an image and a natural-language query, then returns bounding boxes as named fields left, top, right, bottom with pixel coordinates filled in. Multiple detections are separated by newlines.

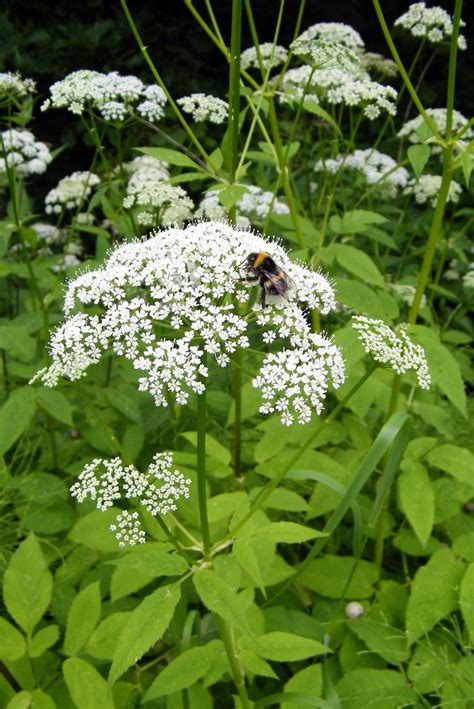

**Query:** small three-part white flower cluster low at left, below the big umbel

left=71, top=453, right=191, bottom=547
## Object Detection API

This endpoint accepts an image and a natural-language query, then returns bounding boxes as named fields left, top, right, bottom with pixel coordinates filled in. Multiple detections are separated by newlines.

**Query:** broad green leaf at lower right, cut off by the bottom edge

left=336, top=668, right=417, bottom=709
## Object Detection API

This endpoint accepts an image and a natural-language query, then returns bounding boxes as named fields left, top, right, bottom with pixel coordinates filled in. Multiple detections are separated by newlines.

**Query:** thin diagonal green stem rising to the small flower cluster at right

left=218, top=363, right=377, bottom=550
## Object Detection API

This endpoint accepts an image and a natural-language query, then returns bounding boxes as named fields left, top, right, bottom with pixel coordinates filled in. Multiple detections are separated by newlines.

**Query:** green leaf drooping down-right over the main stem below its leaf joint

left=193, top=569, right=252, bottom=635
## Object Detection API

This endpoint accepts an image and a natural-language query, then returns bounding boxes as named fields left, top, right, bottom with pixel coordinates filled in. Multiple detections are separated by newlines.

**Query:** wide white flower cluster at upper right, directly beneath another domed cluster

left=279, top=64, right=397, bottom=120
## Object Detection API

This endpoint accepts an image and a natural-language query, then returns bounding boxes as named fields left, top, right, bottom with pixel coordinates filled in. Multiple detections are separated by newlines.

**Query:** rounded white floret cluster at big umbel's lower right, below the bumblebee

left=252, top=333, right=345, bottom=426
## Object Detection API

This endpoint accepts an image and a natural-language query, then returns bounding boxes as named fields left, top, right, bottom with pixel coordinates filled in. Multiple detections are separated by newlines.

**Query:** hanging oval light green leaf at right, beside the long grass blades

left=398, top=460, right=435, bottom=547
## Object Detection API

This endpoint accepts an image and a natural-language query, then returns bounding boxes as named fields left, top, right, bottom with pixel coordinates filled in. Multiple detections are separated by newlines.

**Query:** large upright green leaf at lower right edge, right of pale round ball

left=406, top=548, right=464, bottom=644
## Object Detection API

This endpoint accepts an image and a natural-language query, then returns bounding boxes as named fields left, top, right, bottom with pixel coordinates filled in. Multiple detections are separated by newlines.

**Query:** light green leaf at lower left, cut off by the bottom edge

left=63, top=657, right=115, bottom=709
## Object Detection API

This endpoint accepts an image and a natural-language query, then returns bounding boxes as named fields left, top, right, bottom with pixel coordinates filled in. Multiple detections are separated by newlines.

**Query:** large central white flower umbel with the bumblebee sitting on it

left=36, top=222, right=343, bottom=424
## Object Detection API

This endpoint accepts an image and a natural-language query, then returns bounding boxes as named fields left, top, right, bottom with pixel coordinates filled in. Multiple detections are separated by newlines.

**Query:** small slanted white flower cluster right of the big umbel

left=352, top=315, right=431, bottom=389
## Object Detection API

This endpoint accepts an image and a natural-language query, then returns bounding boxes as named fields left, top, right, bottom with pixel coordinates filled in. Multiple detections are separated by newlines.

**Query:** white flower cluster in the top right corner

left=394, top=2, right=467, bottom=49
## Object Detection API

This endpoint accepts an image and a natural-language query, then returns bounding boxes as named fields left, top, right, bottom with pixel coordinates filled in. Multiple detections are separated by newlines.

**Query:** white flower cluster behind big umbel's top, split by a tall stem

left=195, top=185, right=290, bottom=227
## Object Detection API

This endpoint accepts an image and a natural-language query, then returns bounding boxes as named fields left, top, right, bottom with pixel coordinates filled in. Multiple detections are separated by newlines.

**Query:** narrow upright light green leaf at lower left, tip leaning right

left=64, top=581, right=101, bottom=655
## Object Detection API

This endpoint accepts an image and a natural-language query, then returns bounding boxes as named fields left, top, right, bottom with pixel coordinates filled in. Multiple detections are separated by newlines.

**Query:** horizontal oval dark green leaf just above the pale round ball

left=299, top=554, right=379, bottom=599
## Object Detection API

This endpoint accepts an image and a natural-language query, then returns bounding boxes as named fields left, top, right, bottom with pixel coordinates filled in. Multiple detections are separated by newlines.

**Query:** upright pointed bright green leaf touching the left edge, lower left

left=3, top=533, right=53, bottom=634
